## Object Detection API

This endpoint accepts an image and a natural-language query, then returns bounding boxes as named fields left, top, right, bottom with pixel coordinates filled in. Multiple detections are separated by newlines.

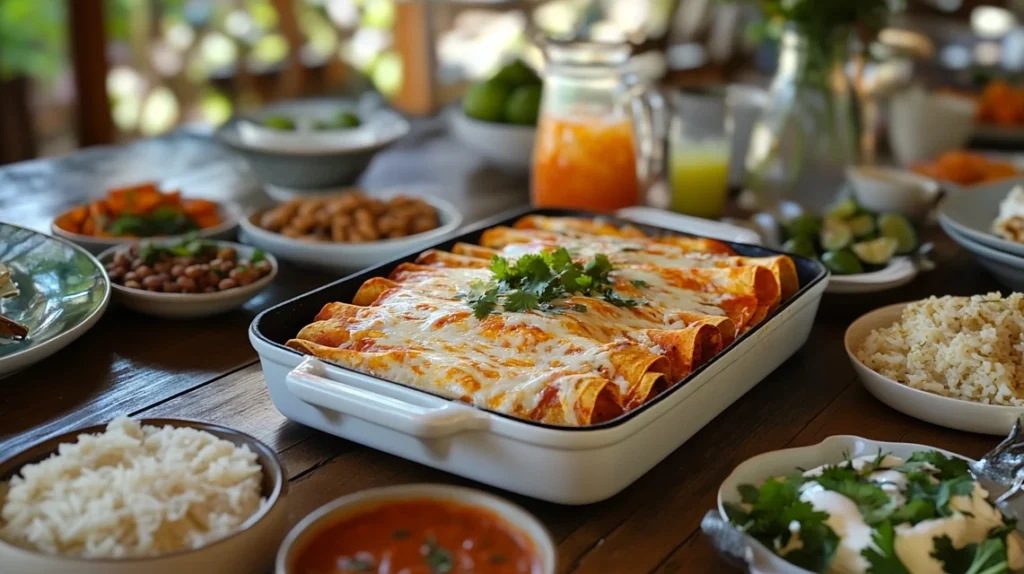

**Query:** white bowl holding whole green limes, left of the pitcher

left=449, top=107, right=537, bottom=173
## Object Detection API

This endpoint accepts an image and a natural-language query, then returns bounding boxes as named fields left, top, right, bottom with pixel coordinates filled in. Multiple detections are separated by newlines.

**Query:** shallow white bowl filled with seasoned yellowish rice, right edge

left=845, top=293, right=1024, bottom=436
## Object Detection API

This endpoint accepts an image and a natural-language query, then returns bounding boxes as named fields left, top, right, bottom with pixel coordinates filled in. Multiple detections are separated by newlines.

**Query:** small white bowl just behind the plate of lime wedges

left=846, top=166, right=939, bottom=218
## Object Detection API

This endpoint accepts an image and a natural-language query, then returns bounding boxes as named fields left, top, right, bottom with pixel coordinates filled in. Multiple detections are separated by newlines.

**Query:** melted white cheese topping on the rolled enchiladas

left=289, top=214, right=794, bottom=426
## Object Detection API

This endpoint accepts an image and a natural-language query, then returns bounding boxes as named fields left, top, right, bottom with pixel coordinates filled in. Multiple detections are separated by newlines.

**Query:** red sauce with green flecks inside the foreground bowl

left=291, top=499, right=541, bottom=574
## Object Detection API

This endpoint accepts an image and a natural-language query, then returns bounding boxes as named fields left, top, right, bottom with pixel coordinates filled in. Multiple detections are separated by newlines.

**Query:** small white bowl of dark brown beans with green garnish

left=98, top=238, right=278, bottom=318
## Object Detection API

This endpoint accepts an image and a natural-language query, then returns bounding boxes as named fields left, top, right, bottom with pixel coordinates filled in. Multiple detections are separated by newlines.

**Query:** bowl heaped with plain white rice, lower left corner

left=0, top=417, right=288, bottom=574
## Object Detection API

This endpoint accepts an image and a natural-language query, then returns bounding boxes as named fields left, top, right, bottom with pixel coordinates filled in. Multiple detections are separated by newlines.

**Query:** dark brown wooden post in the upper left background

left=67, top=0, right=114, bottom=147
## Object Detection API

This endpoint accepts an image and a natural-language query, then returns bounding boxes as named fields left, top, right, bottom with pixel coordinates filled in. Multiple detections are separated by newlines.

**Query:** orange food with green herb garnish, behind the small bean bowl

left=54, top=183, right=222, bottom=237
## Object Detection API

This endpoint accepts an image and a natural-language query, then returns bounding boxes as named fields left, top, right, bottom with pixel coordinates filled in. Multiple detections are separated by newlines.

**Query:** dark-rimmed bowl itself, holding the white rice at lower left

left=0, top=418, right=288, bottom=574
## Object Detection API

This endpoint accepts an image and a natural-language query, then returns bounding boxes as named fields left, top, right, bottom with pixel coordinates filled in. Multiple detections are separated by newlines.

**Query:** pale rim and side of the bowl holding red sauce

left=274, top=484, right=555, bottom=574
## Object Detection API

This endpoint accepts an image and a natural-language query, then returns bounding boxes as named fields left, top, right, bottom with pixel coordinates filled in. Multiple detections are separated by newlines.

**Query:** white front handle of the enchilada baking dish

left=285, top=357, right=487, bottom=439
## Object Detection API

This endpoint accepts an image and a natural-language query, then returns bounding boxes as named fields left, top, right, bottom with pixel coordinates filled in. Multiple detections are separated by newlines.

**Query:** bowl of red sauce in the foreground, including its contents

left=275, top=484, right=555, bottom=574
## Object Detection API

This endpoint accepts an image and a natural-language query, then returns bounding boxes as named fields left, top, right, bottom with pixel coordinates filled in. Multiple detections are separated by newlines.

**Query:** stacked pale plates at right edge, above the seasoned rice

left=938, top=182, right=1024, bottom=291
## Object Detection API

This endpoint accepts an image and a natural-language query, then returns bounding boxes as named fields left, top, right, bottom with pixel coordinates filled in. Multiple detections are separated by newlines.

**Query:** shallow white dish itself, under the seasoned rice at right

left=844, top=303, right=1024, bottom=436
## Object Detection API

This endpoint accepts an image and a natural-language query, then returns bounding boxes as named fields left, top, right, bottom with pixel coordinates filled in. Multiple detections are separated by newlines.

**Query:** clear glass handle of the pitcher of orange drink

left=625, top=82, right=669, bottom=192
